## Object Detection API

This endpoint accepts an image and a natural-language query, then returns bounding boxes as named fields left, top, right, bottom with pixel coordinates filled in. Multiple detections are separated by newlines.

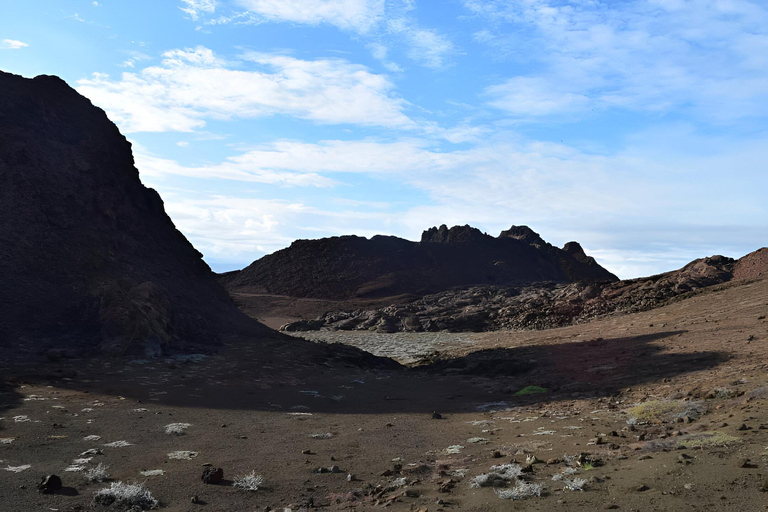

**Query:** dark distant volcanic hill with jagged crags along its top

left=221, top=225, right=617, bottom=299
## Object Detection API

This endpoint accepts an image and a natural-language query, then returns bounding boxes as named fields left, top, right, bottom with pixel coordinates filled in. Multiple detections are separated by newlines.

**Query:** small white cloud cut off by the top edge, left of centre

left=238, top=0, right=384, bottom=34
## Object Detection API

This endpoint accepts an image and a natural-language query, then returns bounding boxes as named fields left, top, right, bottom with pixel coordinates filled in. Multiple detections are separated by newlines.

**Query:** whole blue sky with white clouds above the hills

left=0, top=0, right=768, bottom=278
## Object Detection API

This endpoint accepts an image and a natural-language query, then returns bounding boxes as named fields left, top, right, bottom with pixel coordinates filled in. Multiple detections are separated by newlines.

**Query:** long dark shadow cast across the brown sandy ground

left=3, top=331, right=729, bottom=414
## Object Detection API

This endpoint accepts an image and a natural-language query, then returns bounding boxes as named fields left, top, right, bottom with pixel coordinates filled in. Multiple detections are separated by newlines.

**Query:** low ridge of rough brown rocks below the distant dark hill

left=281, top=249, right=768, bottom=333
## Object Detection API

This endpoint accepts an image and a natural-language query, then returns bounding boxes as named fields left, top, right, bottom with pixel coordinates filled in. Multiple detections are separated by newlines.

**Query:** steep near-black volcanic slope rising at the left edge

left=0, top=72, right=267, bottom=353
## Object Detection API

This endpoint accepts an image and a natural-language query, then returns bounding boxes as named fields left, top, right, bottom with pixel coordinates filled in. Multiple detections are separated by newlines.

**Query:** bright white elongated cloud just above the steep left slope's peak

left=77, top=47, right=416, bottom=132
